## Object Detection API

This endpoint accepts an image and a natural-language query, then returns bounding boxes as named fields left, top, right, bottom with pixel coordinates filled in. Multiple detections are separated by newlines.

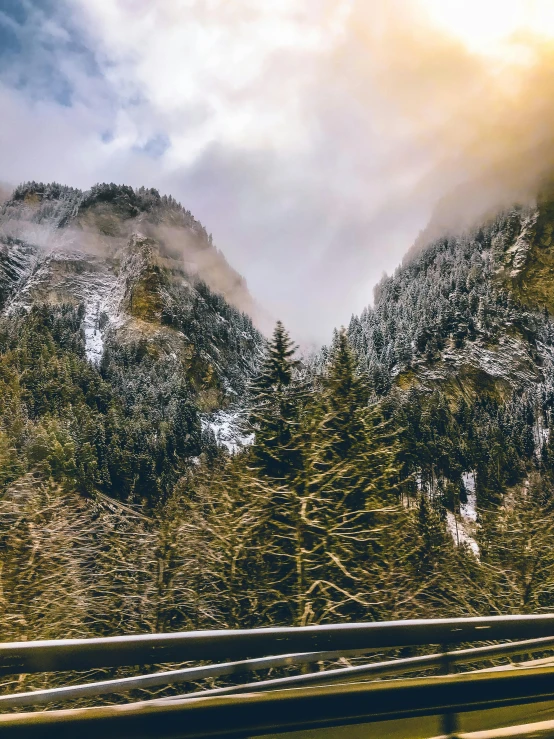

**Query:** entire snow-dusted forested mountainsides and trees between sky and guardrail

left=5, top=184, right=554, bottom=704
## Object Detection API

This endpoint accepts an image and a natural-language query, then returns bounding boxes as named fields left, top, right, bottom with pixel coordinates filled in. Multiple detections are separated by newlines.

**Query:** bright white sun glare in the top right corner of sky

left=423, top=0, right=554, bottom=54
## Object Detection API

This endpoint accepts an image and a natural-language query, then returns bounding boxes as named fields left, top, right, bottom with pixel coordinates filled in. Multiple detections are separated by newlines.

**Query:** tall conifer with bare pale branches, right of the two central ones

left=272, top=331, right=397, bottom=625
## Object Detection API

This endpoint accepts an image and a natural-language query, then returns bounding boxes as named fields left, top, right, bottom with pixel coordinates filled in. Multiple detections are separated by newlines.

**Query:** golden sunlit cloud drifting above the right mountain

left=333, top=0, right=554, bottom=248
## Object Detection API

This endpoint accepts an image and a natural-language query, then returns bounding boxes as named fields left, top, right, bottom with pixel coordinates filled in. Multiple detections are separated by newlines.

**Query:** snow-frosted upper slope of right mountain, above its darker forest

left=349, top=202, right=554, bottom=397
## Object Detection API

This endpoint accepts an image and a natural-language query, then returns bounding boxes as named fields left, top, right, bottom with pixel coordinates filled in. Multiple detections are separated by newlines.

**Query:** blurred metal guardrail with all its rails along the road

left=5, top=615, right=554, bottom=739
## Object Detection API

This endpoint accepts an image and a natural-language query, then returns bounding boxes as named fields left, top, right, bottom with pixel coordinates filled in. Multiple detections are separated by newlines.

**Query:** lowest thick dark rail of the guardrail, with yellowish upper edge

left=4, top=668, right=554, bottom=739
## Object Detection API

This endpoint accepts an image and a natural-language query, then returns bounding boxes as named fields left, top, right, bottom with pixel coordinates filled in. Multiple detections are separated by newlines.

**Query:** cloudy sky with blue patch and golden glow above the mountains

left=0, top=0, right=554, bottom=341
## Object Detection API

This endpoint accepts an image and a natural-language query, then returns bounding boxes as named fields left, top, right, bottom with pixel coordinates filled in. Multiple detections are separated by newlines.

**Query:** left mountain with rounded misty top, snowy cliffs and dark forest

left=0, top=182, right=265, bottom=502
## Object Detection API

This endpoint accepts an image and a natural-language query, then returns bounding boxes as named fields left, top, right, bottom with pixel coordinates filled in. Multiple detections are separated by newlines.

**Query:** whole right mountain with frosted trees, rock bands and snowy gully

left=340, top=189, right=554, bottom=552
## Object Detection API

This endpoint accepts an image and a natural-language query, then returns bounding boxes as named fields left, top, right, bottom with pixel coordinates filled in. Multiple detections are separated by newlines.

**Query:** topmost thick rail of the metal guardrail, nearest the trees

left=5, top=614, right=554, bottom=675
